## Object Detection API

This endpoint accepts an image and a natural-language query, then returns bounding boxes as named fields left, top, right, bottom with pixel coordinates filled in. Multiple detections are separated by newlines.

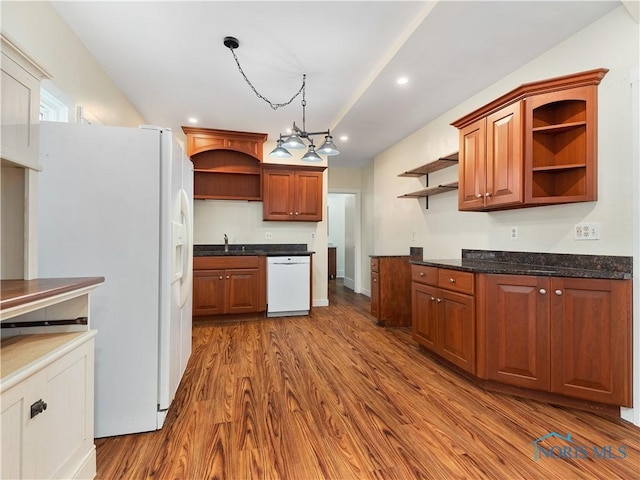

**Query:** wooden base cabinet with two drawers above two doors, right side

left=411, top=265, right=476, bottom=374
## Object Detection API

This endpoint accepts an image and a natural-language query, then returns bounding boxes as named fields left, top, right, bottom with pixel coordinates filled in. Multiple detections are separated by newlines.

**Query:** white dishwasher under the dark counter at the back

left=267, top=255, right=311, bottom=317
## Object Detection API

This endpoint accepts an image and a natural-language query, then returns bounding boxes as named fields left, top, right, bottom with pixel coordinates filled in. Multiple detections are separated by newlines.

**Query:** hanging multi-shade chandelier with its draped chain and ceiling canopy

left=223, top=37, right=340, bottom=162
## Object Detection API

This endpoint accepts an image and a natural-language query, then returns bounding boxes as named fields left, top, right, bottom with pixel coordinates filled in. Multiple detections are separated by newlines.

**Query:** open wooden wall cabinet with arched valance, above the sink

left=182, top=127, right=267, bottom=201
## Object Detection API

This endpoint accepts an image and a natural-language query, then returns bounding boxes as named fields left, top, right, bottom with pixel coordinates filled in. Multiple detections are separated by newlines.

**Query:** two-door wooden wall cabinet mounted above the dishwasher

left=262, top=164, right=326, bottom=222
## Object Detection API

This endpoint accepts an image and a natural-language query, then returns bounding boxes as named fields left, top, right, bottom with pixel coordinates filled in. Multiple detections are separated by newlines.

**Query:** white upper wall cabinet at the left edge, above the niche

left=0, top=36, right=50, bottom=169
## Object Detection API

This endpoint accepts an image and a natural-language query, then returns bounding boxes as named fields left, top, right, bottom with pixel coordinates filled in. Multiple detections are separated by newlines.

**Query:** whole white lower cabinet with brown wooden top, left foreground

left=0, top=277, right=104, bottom=479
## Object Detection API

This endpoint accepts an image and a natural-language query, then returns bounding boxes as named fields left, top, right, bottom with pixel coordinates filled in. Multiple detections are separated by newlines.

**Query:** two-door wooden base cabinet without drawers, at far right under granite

left=479, top=275, right=632, bottom=407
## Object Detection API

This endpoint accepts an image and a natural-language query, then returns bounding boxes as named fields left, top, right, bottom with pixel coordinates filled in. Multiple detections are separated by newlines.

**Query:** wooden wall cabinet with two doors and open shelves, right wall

left=452, top=68, right=608, bottom=211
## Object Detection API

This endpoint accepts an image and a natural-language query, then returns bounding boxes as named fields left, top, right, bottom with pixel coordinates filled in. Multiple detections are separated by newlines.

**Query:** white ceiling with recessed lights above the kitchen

left=53, top=0, right=620, bottom=166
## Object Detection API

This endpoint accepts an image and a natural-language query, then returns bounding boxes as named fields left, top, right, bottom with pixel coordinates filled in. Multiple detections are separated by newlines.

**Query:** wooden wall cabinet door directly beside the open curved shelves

left=485, top=102, right=523, bottom=208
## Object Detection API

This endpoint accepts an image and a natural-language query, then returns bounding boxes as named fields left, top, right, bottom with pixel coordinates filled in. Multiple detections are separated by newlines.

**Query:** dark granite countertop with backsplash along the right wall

left=411, top=250, right=633, bottom=280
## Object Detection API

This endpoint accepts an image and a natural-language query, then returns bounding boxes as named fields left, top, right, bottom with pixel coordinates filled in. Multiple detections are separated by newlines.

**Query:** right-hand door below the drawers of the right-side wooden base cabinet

left=436, top=289, right=476, bottom=374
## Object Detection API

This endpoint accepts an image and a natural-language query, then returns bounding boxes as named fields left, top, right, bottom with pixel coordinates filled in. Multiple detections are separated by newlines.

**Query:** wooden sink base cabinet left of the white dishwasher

left=193, top=256, right=266, bottom=316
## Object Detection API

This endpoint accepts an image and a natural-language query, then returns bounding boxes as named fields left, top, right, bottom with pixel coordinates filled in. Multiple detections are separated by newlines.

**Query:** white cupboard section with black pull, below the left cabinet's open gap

left=0, top=331, right=95, bottom=479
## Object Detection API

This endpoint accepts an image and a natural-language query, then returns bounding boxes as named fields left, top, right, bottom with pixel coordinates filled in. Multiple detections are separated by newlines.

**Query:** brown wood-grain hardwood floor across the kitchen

left=96, top=280, right=640, bottom=480
